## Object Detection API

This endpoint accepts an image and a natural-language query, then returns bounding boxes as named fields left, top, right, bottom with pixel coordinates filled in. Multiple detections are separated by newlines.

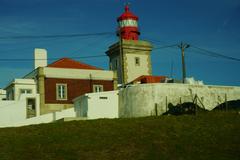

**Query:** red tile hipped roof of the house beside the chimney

left=47, top=58, right=102, bottom=70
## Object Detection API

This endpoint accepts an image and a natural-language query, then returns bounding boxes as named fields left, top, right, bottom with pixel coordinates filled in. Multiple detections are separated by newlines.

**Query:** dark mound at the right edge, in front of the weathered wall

left=213, top=100, right=240, bottom=111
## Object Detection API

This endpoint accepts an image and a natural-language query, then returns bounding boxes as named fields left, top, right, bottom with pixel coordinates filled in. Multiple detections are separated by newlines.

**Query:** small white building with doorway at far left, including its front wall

left=0, top=79, right=40, bottom=127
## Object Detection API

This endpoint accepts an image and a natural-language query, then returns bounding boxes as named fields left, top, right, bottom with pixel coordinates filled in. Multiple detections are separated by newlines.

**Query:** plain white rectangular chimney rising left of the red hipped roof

left=34, top=48, right=47, bottom=69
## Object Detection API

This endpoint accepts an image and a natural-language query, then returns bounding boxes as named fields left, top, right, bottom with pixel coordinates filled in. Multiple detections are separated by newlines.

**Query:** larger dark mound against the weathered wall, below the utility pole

left=163, top=102, right=207, bottom=115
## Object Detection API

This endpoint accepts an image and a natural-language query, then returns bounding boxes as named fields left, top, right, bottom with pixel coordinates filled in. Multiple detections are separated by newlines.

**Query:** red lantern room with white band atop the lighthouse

left=117, top=5, right=140, bottom=40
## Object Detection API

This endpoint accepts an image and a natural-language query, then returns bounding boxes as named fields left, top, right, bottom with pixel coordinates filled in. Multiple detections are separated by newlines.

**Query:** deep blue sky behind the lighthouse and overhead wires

left=0, top=0, right=240, bottom=88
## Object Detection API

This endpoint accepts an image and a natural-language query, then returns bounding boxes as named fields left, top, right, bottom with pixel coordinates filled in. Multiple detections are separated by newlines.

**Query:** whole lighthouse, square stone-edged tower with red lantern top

left=106, top=5, right=152, bottom=86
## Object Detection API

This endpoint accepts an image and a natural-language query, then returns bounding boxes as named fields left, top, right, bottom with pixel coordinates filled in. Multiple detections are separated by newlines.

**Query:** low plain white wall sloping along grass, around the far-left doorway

left=0, top=94, right=76, bottom=128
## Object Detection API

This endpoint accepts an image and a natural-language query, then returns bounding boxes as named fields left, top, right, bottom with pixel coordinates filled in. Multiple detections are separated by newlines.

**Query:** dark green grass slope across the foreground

left=0, top=113, right=240, bottom=160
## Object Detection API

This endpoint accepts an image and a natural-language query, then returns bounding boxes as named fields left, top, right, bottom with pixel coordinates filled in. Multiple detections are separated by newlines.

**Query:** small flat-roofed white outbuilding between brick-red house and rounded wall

left=73, top=91, right=118, bottom=119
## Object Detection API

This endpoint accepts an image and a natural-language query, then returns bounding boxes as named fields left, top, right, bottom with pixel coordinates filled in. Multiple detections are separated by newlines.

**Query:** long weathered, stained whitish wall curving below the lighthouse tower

left=119, top=83, right=240, bottom=117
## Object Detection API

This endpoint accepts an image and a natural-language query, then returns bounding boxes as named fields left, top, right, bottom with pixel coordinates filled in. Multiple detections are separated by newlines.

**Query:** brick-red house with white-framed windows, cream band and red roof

left=24, top=58, right=116, bottom=114
